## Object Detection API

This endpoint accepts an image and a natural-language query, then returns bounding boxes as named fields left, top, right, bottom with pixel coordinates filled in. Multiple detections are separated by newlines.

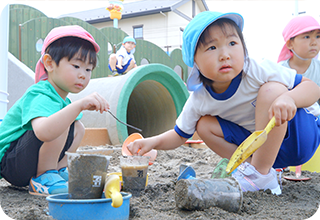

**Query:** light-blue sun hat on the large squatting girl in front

left=182, top=11, right=243, bottom=67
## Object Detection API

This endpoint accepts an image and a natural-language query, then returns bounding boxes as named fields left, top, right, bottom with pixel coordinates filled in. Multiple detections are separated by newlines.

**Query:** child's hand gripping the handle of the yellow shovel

left=269, top=94, right=297, bottom=126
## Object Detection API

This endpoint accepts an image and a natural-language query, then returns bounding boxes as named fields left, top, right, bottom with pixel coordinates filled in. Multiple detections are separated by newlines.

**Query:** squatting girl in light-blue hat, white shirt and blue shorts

left=128, top=11, right=320, bottom=195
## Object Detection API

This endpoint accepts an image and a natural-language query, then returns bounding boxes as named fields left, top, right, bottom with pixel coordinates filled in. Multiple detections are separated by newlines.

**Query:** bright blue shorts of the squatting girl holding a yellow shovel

left=217, top=108, right=320, bottom=168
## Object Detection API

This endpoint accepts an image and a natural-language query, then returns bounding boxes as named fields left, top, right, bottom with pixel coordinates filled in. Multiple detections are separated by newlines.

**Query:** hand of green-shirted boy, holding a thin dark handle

left=79, top=92, right=110, bottom=113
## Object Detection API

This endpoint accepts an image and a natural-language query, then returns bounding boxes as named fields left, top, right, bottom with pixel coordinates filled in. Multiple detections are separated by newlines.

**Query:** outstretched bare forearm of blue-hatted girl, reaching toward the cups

left=128, top=130, right=187, bottom=155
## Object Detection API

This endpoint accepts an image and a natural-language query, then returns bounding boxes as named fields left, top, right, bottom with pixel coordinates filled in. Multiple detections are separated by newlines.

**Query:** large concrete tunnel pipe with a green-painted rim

left=69, top=64, right=189, bottom=145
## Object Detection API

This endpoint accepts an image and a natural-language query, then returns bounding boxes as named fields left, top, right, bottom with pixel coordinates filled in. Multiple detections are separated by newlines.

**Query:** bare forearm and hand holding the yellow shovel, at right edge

left=269, top=77, right=320, bottom=126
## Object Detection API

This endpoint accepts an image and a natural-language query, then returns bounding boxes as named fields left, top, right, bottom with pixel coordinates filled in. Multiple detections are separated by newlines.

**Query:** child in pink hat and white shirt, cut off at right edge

left=278, top=15, right=320, bottom=86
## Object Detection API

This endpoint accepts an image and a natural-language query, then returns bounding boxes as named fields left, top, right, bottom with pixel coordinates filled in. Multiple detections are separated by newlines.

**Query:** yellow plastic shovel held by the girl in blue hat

left=226, top=117, right=276, bottom=174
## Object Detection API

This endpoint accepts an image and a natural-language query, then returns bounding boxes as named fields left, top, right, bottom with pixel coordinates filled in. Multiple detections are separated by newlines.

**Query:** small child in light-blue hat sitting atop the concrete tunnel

left=109, top=36, right=137, bottom=76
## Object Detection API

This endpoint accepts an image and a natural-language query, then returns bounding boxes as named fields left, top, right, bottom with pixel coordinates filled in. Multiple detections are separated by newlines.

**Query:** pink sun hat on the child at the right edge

left=278, top=15, right=320, bottom=63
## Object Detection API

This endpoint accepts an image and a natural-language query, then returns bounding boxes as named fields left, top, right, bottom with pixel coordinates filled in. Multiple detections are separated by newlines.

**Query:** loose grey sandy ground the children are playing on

left=0, top=146, right=320, bottom=220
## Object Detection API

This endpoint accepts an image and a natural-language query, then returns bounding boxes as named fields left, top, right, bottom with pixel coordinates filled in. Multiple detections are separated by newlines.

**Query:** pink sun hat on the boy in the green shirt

left=34, top=25, right=100, bottom=83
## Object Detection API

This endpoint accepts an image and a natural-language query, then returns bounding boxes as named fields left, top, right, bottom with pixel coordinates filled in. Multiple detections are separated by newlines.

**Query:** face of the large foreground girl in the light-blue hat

left=194, top=25, right=244, bottom=93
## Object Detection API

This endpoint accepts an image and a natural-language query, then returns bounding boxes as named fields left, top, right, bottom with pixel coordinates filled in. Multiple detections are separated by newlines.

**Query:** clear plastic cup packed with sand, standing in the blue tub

left=66, top=152, right=111, bottom=199
